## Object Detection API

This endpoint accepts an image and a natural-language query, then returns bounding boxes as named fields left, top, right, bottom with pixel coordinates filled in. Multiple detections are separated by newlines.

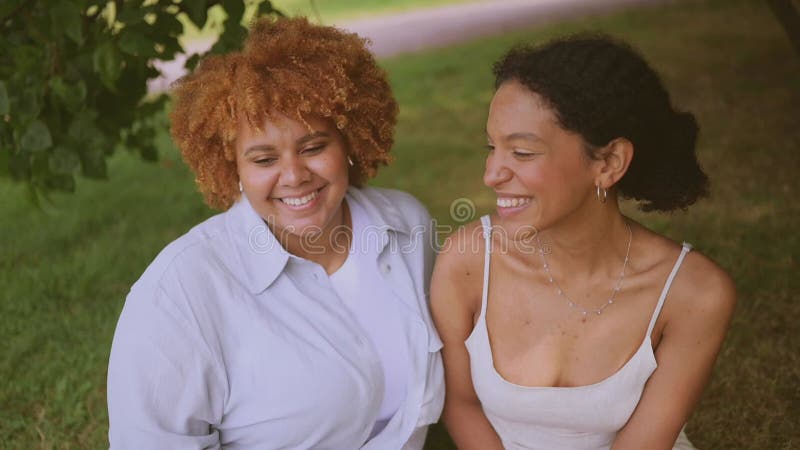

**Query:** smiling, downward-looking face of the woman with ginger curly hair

left=236, top=113, right=348, bottom=242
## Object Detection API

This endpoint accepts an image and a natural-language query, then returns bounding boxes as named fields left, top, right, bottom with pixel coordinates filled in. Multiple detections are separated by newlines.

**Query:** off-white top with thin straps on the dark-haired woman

left=465, top=216, right=694, bottom=450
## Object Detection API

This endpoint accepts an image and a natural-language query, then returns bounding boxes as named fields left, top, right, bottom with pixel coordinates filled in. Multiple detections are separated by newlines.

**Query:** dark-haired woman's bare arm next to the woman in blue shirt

left=431, top=229, right=503, bottom=450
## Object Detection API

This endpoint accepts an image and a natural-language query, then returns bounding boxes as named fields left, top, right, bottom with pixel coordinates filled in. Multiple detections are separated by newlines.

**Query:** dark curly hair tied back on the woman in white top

left=494, top=33, right=708, bottom=211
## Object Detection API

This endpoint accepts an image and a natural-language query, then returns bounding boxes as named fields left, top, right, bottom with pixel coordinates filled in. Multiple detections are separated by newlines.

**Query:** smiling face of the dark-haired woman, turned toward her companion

left=483, top=81, right=596, bottom=236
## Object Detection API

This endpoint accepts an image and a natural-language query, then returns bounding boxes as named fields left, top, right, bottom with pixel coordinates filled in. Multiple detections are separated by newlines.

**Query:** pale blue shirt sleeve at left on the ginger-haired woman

left=107, top=288, right=226, bottom=450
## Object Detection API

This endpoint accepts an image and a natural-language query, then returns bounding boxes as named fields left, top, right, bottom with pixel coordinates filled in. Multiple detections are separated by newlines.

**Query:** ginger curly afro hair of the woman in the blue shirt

left=170, top=18, right=397, bottom=209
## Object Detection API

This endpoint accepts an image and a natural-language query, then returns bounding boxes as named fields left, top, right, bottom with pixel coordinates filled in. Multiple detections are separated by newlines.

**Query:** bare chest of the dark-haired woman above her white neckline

left=485, top=258, right=659, bottom=386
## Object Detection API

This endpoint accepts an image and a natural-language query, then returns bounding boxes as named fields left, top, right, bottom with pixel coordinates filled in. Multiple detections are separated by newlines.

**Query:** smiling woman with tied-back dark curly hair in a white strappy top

left=431, top=35, right=735, bottom=450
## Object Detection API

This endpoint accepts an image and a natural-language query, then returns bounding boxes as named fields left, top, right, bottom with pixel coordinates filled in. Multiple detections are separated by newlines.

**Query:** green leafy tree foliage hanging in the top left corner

left=0, top=0, right=281, bottom=200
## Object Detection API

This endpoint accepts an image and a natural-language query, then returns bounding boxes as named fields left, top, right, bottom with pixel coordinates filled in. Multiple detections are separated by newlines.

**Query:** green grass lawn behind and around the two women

left=0, top=0, right=800, bottom=450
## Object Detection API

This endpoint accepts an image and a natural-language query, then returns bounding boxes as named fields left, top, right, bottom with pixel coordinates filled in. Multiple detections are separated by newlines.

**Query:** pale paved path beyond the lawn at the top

left=148, top=0, right=663, bottom=91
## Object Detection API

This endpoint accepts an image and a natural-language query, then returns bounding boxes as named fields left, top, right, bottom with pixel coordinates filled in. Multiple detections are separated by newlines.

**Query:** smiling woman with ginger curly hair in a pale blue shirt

left=108, top=15, right=444, bottom=450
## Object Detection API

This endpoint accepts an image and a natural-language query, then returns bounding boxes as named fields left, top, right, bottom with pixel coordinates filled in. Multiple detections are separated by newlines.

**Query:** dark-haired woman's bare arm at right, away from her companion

left=612, top=254, right=736, bottom=450
